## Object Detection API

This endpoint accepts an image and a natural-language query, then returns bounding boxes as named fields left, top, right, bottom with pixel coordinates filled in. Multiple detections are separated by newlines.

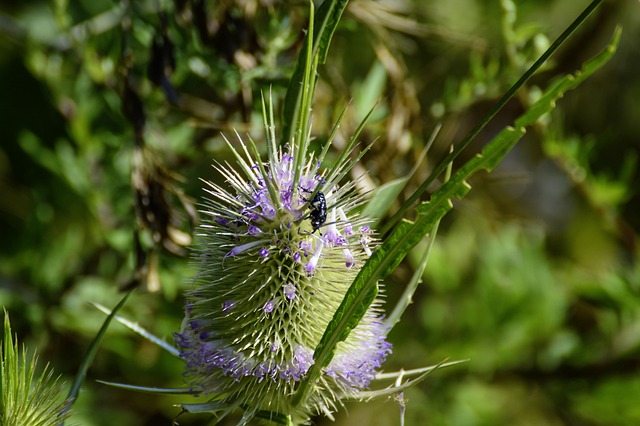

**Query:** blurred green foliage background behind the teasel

left=0, top=0, right=640, bottom=426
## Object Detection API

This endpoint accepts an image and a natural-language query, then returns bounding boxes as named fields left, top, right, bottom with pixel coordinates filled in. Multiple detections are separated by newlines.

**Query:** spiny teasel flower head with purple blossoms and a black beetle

left=175, top=107, right=391, bottom=423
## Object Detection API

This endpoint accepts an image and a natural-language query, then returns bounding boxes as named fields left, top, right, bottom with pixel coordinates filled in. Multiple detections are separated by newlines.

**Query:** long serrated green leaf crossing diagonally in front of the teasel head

left=293, top=20, right=620, bottom=412
